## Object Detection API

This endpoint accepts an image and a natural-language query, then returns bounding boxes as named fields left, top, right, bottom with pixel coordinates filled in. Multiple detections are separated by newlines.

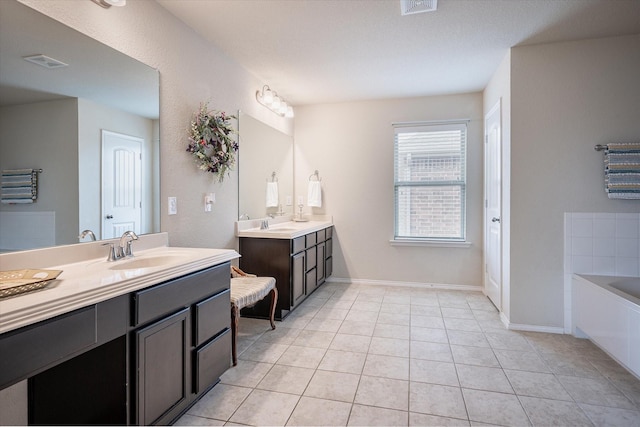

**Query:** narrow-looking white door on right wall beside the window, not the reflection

left=484, top=101, right=502, bottom=311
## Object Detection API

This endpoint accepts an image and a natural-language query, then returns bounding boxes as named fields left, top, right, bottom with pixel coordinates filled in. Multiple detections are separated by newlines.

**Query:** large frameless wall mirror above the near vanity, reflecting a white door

left=0, top=1, right=160, bottom=252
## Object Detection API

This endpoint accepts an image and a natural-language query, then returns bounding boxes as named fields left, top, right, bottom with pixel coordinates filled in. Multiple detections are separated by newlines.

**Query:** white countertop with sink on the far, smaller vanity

left=236, top=215, right=333, bottom=239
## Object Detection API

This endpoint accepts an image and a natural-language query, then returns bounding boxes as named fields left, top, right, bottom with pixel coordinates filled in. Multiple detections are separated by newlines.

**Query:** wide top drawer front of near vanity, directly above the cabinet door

left=132, top=262, right=230, bottom=326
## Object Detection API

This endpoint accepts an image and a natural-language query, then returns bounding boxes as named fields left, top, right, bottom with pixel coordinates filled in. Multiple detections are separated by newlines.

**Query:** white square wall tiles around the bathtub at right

left=564, top=212, right=640, bottom=334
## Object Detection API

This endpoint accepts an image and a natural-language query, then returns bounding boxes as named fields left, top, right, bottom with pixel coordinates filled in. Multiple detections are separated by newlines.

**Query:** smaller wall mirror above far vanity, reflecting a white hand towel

left=238, top=112, right=293, bottom=219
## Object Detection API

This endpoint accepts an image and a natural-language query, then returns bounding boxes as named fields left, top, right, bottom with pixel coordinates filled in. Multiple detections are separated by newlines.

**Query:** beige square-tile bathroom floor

left=177, top=283, right=640, bottom=427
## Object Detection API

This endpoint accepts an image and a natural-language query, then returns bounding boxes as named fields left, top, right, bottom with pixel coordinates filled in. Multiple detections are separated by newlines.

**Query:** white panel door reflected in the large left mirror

left=101, top=130, right=143, bottom=239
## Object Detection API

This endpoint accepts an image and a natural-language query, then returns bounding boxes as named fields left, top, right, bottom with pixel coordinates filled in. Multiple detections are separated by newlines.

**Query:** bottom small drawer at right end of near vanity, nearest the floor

left=194, top=329, right=231, bottom=393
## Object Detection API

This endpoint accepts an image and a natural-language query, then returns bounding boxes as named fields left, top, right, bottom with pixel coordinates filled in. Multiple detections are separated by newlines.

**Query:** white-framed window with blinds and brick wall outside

left=394, top=122, right=467, bottom=242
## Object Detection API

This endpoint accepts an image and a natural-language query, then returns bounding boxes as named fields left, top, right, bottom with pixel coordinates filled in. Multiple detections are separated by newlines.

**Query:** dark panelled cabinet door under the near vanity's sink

left=134, top=308, right=191, bottom=425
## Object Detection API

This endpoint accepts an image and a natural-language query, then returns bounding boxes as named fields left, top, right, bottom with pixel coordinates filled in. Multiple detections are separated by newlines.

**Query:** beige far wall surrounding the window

left=294, top=93, right=483, bottom=286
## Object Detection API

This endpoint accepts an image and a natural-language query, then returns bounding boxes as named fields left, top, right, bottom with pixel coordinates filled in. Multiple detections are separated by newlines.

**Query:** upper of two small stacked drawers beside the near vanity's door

left=194, top=289, right=231, bottom=347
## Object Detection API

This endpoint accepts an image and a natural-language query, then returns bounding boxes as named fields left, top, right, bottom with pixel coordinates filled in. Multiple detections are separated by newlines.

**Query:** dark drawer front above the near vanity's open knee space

left=0, top=305, right=97, bottom=389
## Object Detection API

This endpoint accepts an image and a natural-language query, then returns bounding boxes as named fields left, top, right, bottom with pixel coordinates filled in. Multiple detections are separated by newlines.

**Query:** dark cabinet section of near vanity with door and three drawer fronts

left=132, top=263, right=231, bottom=425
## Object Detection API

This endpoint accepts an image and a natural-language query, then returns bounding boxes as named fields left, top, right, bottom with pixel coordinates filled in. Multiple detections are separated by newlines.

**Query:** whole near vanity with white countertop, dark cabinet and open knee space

left=0, top=236, right=238, bottom=425
